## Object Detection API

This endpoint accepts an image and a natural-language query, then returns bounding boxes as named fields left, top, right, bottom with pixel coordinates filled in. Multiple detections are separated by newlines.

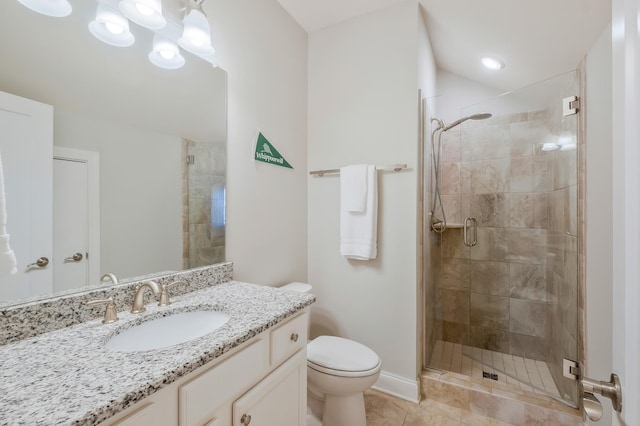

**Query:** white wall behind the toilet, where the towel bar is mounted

left=308, top=1, right=430, bottom=400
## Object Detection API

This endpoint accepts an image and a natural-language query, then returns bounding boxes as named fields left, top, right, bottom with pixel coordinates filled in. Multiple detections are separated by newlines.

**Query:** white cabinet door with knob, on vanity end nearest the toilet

left=233, top=349, right=307, bottom=426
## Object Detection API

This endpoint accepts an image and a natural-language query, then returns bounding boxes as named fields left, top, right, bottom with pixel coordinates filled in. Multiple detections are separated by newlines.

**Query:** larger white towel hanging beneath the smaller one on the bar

left=340, top=165, right=378, bottom=260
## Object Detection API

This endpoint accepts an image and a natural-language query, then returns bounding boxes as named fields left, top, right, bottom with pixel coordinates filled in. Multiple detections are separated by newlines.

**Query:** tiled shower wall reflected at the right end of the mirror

left=182, top=139, right=227, bottom=268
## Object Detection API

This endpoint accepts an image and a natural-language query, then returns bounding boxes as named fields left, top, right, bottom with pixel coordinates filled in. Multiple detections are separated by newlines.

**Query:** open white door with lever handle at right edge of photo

left=612, top=0, right=640, bottom=425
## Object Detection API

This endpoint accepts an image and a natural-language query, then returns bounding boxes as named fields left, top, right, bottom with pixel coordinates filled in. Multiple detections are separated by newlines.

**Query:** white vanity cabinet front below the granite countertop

left=103, top=309, right=309, bottom=426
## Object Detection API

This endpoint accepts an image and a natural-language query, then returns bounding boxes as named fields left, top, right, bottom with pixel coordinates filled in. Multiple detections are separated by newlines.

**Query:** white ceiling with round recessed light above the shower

left=278, top=0, right=611, bottom=92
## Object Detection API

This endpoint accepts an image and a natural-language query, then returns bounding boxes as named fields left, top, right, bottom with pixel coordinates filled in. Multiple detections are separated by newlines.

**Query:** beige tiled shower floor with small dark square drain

left=429, top=340, right=560, bottom=398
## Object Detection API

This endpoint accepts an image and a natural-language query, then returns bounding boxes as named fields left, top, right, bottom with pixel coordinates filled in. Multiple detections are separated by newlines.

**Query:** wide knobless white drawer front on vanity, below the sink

left=179, top=339, right=269, bottom=426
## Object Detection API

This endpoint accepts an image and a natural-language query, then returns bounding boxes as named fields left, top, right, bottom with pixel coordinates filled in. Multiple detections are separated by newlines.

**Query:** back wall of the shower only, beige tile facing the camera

left=440, top=111, right=551, bottom=359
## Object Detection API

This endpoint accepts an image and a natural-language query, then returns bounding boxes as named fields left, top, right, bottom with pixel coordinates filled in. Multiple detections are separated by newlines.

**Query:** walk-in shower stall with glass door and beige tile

left=423, top=72, right=579, bottom=406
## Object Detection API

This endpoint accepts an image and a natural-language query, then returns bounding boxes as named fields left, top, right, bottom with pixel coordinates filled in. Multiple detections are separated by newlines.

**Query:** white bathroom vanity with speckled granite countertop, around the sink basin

left=0, top=274, right=315, bottom=426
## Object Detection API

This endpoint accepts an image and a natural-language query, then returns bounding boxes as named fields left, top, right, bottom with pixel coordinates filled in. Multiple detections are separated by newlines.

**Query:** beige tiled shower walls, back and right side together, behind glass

left=436, top=80, right=578, bottom=399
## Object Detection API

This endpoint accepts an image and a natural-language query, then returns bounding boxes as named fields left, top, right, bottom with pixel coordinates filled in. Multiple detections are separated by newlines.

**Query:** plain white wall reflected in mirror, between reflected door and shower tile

left=53, top=108, right=182, bottom=277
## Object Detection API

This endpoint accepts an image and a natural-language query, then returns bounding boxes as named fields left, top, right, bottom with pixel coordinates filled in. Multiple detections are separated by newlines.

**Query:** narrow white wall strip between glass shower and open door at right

left=585, top=26, right=613, bottom=425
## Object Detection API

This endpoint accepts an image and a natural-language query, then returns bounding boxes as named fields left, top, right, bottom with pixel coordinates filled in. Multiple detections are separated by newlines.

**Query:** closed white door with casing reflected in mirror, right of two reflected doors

left=52, top=146, right=100, bottom=292
